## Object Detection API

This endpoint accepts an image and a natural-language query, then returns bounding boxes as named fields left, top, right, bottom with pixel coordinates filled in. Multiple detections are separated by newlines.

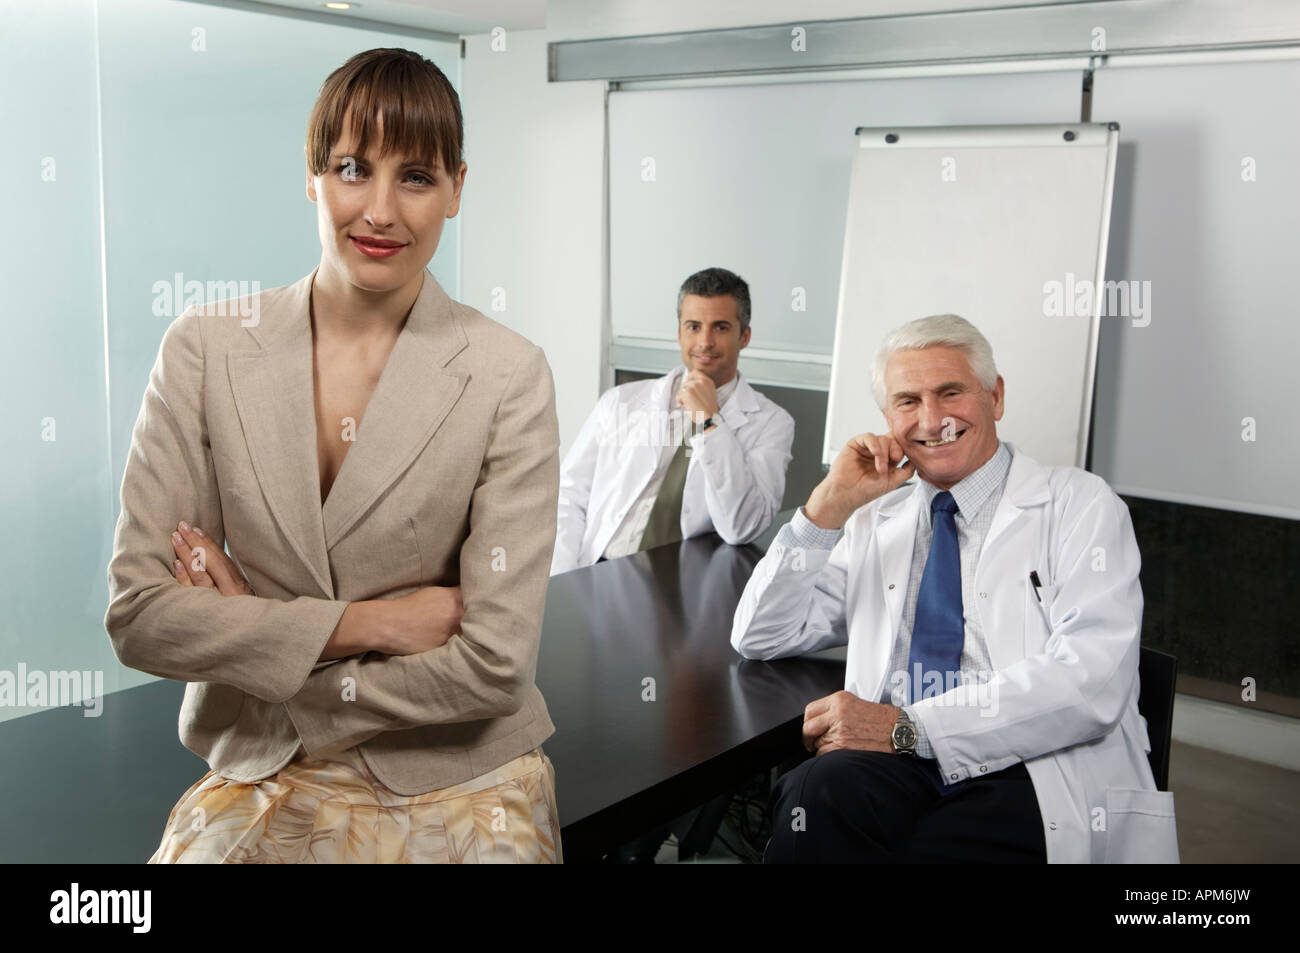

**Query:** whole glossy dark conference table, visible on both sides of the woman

left=0, top=512, right=844, bottom=863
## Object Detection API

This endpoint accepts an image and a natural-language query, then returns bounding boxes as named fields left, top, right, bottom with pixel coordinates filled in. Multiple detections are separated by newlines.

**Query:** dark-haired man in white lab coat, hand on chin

left=551, top=268, right=794, bottom=576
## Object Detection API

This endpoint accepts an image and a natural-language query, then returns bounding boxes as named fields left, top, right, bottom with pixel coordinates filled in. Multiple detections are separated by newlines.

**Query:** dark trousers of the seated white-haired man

left=763, top=750, right=1047, bottom=863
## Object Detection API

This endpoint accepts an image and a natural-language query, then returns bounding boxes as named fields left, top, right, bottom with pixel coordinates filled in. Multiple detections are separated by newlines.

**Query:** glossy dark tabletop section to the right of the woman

left=537, top=515, right=844, bottom=861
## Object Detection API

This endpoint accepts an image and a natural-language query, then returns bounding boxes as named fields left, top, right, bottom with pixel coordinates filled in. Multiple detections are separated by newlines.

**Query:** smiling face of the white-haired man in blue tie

left=884, top=347, right=1002, bottom=490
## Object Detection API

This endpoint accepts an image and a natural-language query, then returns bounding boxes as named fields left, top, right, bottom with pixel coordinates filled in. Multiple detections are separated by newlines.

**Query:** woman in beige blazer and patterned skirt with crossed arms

left=105, top=49, right=562, bottom=863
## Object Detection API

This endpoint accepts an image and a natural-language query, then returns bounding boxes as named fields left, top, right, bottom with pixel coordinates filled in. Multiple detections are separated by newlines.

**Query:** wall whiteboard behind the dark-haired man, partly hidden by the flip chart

left=608, top=69, right=1086, bottom=361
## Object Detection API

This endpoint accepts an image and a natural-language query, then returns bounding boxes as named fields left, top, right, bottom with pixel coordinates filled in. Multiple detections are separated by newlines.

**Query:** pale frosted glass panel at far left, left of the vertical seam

left=0, top=0, right=118, bottom=720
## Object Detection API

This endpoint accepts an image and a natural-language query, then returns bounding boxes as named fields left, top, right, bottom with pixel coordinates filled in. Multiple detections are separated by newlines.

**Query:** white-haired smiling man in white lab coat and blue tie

left=732, top=315, right=1178, bottom=863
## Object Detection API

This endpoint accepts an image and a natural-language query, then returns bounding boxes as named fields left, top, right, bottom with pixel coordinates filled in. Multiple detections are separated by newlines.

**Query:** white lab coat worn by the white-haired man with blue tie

left=732, top=452, right=1178, bottom=863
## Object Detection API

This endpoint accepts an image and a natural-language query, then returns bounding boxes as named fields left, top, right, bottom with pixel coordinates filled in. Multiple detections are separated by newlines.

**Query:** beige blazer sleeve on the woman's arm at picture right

left=285, top=347, right=559, bottom=755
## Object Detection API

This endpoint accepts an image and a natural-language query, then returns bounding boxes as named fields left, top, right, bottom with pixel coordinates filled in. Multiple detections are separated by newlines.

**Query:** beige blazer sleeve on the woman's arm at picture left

left=104, top=309, right=350, bottom=702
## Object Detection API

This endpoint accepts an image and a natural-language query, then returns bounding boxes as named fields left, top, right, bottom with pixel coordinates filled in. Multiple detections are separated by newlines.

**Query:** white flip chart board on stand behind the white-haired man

left=823, top=124, right=1119, bottom=467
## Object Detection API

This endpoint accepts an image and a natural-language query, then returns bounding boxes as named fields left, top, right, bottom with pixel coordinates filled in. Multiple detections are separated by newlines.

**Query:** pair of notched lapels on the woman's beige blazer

left=228, top=270, right=468, bottom=598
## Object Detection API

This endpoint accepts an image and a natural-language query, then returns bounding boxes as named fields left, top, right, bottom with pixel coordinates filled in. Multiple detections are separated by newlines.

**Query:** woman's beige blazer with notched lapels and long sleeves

left=104, top=263, right=559, bottom=794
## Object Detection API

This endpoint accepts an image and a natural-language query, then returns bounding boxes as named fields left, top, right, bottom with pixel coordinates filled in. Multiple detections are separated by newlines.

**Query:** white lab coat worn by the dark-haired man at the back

left=551, top=372, right=794, bottom=576
